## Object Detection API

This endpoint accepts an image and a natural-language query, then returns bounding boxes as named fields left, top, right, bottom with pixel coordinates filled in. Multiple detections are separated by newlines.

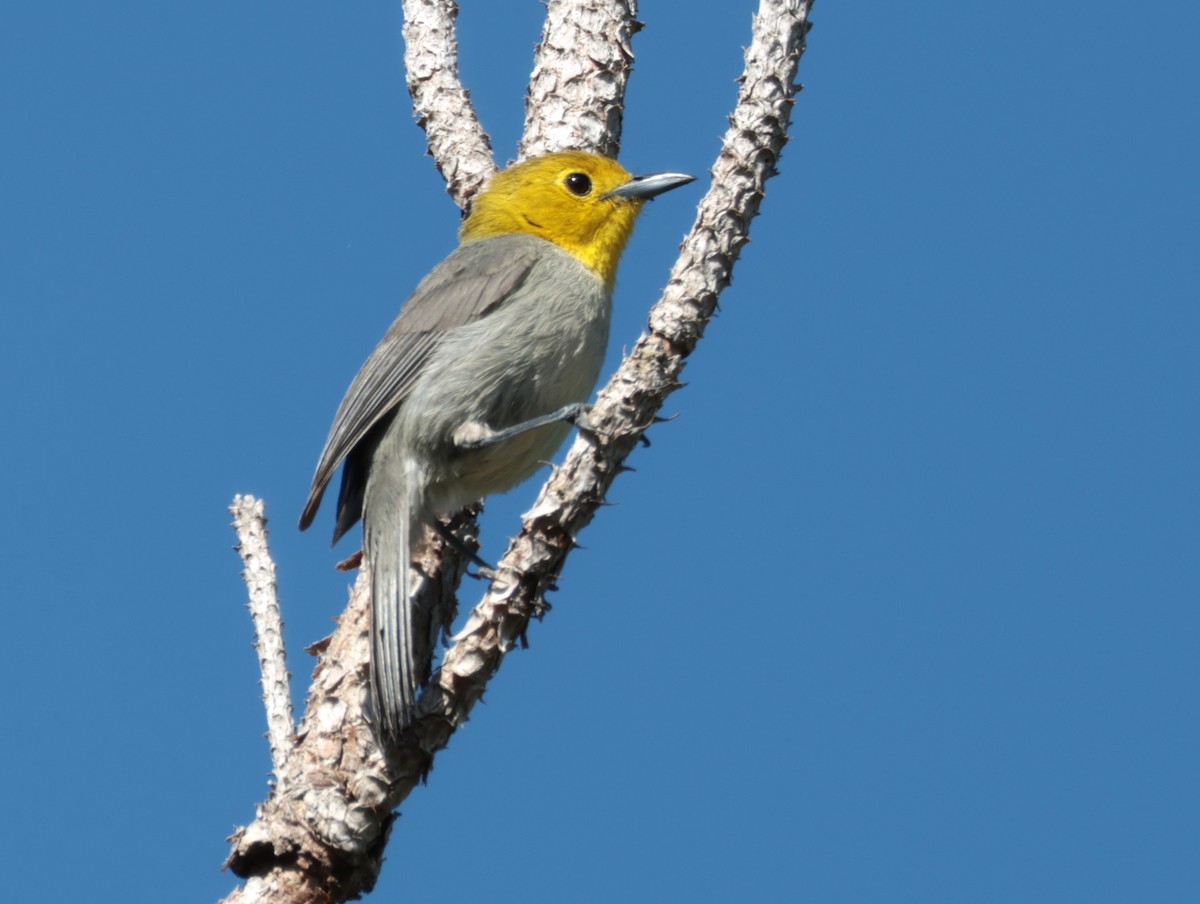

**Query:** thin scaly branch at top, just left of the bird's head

left=402, top=0, right=496, bottom=206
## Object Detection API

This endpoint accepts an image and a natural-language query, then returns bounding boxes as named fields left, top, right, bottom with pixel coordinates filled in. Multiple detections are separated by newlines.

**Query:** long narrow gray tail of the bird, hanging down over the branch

left=362, top=462, right=433, bottom=740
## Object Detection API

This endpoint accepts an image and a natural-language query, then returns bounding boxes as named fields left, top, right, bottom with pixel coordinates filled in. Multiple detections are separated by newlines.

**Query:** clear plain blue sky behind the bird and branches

left=0, top=0, right=1200, bottom=904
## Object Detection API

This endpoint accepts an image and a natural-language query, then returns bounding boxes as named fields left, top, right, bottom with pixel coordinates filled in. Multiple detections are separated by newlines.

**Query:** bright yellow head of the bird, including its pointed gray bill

left=458, top=151, right=692, bottom=286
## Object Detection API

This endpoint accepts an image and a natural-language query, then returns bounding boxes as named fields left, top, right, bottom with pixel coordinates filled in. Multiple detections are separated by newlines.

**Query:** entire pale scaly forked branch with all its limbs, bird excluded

left=226, top=0, right=811, bottom=902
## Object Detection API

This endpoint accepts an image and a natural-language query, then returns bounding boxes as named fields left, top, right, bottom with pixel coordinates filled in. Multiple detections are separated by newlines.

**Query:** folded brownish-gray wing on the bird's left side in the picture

left=300, top=237, right=541, bottom=543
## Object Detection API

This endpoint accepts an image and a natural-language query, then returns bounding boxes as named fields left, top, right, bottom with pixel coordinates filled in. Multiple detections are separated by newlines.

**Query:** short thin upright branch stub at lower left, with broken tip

left=229, top=496, right=295, bottom=789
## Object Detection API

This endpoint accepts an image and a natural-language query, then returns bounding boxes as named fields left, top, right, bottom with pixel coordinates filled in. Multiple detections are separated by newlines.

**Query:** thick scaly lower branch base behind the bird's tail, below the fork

left=226, top=523, right=463, bottom=904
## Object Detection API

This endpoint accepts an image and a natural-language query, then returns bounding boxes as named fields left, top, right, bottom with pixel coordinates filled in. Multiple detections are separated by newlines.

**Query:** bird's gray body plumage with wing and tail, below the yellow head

left=300, top=234, right=611, bottom=737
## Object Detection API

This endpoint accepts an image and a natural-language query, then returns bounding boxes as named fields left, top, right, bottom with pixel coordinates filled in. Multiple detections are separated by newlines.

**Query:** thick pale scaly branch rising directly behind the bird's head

left=518, top=0, right=642, bottom=160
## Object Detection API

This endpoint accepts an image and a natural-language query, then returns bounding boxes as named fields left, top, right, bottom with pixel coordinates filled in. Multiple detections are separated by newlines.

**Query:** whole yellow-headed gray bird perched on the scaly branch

left=300, top=150, right=694, bottom=742
